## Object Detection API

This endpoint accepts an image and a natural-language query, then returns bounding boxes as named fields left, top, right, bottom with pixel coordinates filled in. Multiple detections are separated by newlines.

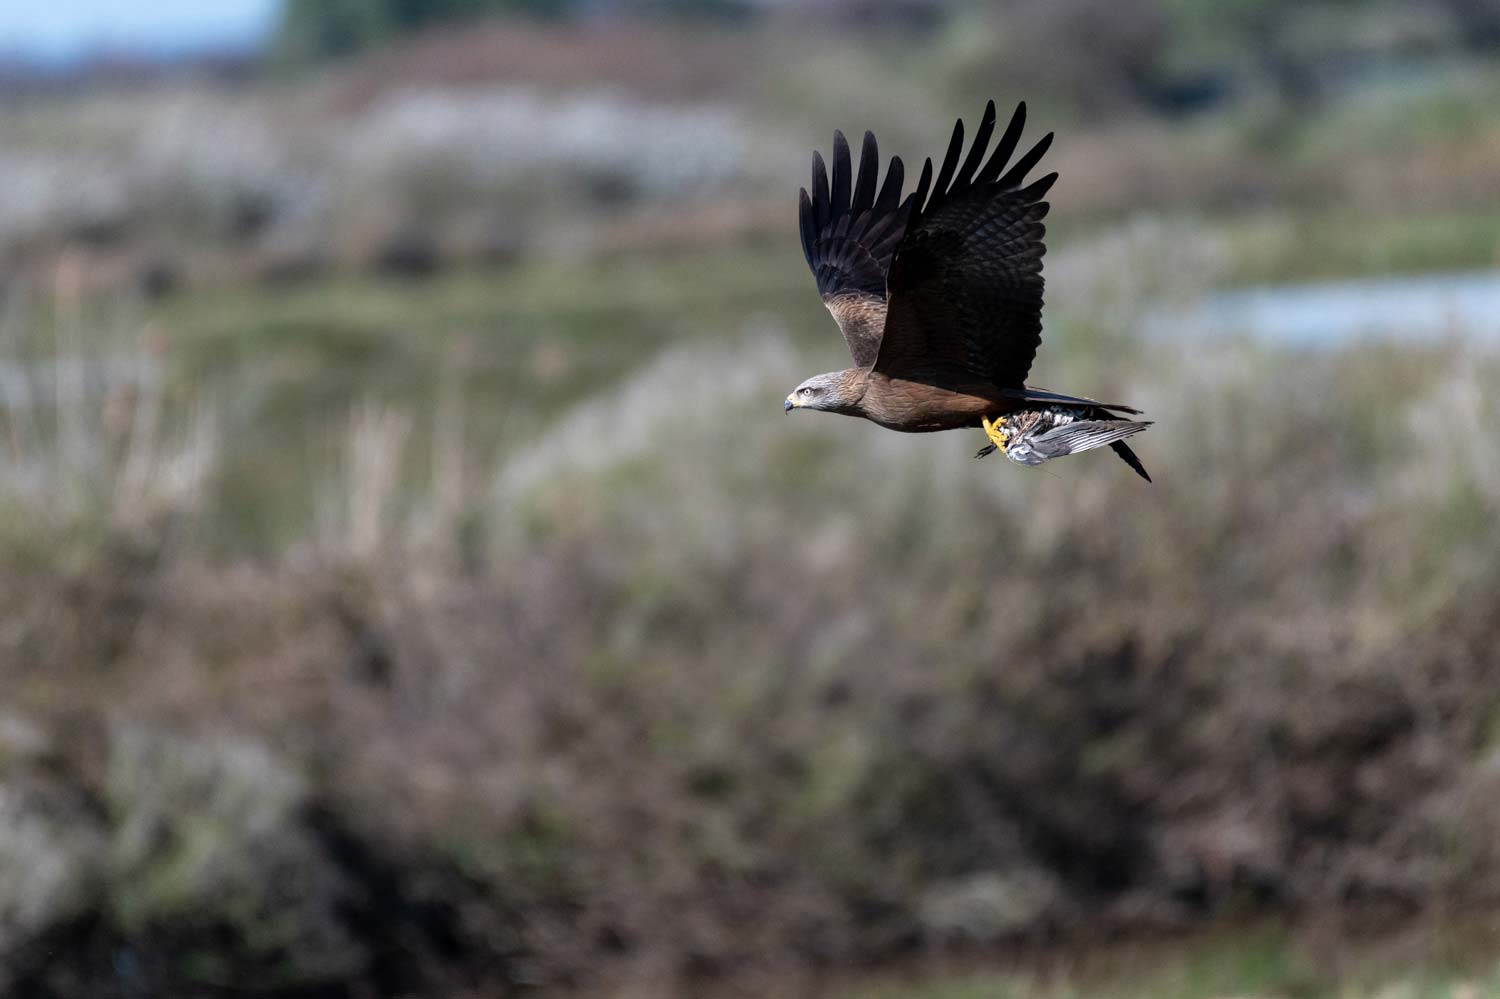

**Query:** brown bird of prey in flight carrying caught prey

left=786, top=101, right=1151, bottom=482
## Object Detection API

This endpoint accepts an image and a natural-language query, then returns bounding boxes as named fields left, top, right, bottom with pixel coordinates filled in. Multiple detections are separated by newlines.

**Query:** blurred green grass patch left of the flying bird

left=127, top=243, right=837, bottom=551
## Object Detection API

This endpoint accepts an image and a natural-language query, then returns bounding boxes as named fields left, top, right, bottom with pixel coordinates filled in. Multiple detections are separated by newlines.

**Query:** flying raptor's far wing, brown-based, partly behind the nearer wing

left=798, top=132, right=912, bottom=368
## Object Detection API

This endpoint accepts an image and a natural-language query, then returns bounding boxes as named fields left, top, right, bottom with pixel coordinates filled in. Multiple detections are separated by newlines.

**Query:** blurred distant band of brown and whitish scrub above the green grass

left=0, top=0, right=1500, bottom=294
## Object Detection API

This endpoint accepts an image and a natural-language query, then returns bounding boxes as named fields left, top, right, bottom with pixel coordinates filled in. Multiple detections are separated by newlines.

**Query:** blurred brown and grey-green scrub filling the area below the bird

left=0, top=228, right=1500, bottom=996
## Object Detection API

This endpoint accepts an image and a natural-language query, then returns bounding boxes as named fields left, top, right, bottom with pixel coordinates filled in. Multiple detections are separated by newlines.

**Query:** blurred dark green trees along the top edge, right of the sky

left=278, top=0, right=1500, bottom=113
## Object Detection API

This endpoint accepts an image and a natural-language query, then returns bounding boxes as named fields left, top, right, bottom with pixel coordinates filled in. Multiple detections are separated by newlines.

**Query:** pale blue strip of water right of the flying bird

left=1146, top=270, right=1500, bottom=347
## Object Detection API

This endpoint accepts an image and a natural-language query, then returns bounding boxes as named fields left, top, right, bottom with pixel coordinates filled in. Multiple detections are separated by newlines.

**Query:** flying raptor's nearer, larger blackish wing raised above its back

left=875, top=101, right=1058, bottom=389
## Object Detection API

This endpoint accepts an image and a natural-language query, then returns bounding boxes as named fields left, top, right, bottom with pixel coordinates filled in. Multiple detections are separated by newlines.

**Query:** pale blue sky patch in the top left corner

left=0, top=0, right=281, bottom=59
